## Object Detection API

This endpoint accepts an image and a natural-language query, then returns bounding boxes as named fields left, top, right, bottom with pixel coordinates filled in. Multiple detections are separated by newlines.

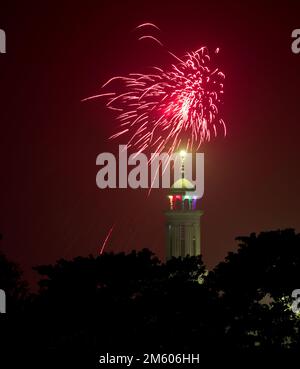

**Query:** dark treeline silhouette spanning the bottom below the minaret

left=0, top=229, right=300, bottom=368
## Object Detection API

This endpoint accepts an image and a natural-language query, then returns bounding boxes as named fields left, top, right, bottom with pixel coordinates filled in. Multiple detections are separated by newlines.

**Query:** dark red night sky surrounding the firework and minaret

left=0, top=0, right=300, bottom=284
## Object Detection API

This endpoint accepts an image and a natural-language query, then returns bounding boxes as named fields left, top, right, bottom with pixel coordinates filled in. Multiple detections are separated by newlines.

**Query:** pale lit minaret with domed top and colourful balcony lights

left=165, top=151, right=203, bottom=260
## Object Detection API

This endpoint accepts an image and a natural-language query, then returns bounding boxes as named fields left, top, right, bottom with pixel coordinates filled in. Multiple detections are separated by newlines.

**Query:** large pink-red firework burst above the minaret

left=85, top=23, right=226, bottom=153
